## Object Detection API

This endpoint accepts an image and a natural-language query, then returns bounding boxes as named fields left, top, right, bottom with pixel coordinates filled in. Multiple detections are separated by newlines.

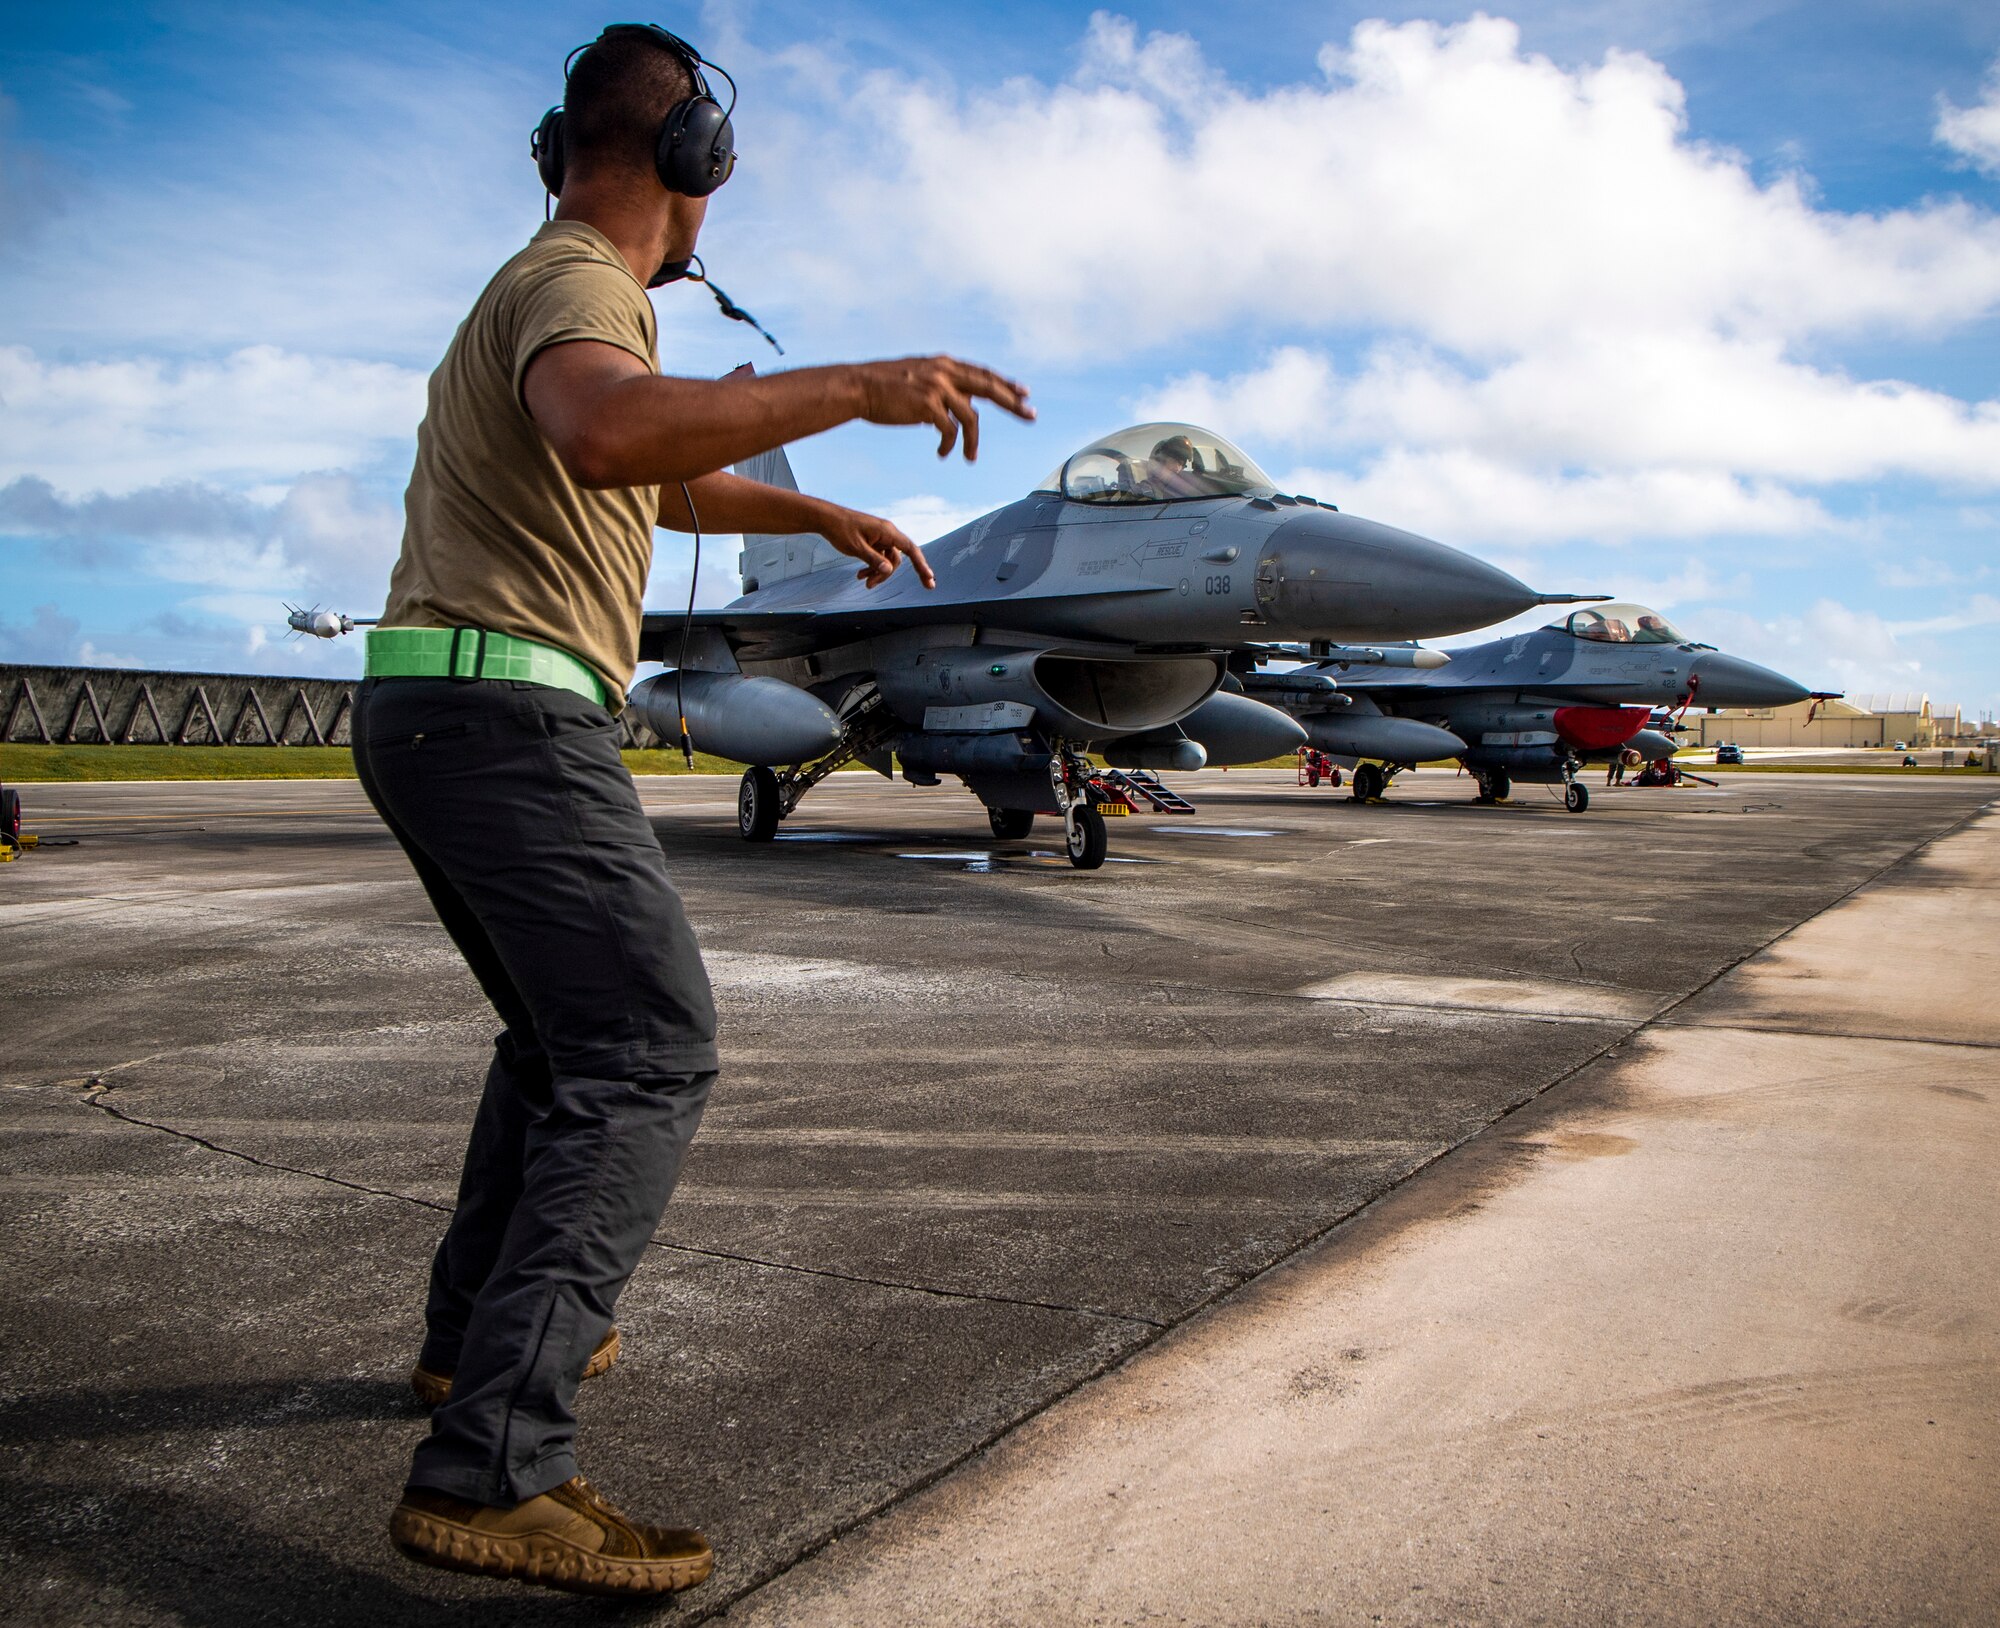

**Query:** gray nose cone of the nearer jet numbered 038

left=1256, top=512, right=1538, bottom=640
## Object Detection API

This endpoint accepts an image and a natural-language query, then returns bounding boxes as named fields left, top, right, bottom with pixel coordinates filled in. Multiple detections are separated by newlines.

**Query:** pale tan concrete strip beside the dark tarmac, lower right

left=732, top=796, right=2000, bottom=1628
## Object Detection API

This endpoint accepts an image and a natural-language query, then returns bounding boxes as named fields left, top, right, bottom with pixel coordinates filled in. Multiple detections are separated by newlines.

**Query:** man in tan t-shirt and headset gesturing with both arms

left=354, top=24, right=1032, bottom=1594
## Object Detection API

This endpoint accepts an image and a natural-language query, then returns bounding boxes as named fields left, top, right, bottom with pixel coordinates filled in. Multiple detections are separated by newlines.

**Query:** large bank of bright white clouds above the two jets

left=752, top=12, right=2000, bottom=580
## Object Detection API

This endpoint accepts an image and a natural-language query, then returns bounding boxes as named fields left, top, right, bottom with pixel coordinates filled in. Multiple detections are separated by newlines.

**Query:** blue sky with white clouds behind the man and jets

left=0, top=0, right=2000, bottom=712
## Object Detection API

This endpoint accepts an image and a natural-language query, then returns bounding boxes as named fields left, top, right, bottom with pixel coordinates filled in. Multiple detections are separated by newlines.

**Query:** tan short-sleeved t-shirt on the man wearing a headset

left=382, top=220, right=660, bottom=712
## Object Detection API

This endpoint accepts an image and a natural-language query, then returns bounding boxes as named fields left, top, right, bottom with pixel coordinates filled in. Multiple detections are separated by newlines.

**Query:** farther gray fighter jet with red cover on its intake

left=1242, top=604, right=1834, bottom=812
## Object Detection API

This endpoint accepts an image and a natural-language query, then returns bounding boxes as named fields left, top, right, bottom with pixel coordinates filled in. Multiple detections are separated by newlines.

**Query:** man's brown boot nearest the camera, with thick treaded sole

left=388, top=1476, right=716, bottom=1594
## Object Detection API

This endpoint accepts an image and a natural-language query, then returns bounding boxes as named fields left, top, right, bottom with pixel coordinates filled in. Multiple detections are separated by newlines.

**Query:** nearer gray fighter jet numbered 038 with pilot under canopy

left=632, top=424, right=1576, bottom=868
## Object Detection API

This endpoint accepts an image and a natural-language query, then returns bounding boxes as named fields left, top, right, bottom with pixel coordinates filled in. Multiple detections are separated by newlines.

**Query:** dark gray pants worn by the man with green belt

left=354, top=678, right=716, bottom=1504
